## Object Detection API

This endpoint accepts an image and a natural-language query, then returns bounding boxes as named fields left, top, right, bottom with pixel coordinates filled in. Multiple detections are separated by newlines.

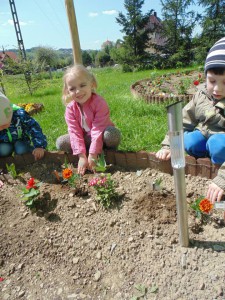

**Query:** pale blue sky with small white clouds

left=0, top=0, right=164, bottom=50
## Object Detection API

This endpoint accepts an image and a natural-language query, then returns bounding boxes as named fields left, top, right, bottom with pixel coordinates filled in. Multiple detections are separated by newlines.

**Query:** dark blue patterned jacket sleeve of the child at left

left=16, top=109, right=47, bottom=149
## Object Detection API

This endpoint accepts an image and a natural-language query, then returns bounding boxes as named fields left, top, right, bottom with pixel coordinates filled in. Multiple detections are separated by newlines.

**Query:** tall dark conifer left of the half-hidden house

left=116, top=0, right=151, bottom=65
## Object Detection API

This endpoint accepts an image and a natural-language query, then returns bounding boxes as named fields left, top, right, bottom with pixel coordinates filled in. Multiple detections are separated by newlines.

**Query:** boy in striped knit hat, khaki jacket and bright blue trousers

left=156, top=37, right=225, bottom=203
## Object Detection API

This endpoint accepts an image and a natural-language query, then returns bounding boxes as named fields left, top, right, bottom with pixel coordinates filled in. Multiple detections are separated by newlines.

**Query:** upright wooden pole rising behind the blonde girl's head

left=65, top=0, right=82, bottom=64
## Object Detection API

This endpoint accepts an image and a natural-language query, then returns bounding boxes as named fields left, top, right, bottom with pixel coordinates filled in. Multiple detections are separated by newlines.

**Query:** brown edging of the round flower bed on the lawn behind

left=130, top=79, right=193, bottom=104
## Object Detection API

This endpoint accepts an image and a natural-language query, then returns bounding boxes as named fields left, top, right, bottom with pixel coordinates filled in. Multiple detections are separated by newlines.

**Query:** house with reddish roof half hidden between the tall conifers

left=146, top=12, right=166, bottom=53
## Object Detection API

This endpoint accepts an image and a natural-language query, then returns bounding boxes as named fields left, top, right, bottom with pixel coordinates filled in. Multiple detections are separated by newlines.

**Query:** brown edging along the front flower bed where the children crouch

left=0, top=150, right=220, bottom=179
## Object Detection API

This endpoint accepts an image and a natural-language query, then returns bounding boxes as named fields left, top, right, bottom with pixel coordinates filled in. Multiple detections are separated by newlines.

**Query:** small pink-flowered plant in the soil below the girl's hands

left=89, top=174, right=118, bottom=208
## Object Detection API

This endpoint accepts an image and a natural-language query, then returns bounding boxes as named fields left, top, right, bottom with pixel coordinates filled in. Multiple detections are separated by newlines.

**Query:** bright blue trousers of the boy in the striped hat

left=184, top=130, right=225, bottom=164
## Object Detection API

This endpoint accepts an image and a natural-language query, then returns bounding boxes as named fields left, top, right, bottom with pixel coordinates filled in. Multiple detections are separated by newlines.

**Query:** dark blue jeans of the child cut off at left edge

left=0, top=140, right=34, bottom=157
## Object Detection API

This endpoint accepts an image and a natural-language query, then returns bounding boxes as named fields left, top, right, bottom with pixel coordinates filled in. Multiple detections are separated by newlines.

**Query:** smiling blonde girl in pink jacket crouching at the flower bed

left=56, top=64, right=121, bottom=175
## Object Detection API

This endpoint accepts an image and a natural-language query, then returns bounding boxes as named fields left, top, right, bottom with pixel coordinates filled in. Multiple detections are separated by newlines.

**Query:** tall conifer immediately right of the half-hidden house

left=161, top=0, right=200, bottom=67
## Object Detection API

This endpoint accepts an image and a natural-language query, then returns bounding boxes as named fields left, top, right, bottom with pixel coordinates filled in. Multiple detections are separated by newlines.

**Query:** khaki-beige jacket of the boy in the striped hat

left=162, top=86, right=225, bottom=190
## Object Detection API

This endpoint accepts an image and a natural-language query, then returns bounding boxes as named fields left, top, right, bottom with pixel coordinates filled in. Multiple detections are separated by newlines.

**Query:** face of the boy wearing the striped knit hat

left=206, top=70, right=225, bottom=100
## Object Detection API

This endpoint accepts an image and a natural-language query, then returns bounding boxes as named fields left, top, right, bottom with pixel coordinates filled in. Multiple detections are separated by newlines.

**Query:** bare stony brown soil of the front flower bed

left=0, top=163, right=225, bottom=300
